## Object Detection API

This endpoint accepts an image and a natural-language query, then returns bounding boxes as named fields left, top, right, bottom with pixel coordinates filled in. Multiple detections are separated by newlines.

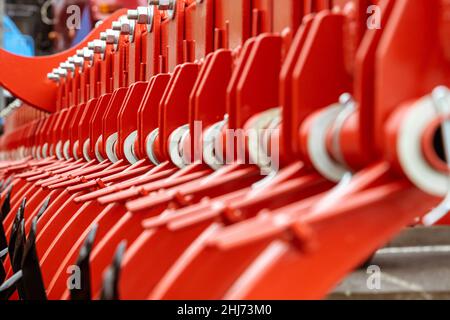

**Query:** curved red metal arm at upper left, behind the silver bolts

left=0, top=9, right=127, bottom=112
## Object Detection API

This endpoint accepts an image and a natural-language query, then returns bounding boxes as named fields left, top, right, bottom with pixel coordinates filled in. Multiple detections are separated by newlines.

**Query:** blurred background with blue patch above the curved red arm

left=0, top=0, right=147, bottom=127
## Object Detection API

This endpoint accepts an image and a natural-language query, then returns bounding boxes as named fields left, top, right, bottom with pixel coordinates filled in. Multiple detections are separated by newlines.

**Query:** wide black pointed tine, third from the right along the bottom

left=22, top=217, right=47, bottom=301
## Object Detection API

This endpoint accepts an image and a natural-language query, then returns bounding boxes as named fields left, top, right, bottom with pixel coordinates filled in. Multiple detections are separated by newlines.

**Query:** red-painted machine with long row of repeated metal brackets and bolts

left=0, top=0, right=449, bottom=299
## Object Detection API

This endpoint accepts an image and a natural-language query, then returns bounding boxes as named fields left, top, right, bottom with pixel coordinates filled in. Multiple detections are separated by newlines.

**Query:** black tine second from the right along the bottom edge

left=70, top=225, right=98, bottom=301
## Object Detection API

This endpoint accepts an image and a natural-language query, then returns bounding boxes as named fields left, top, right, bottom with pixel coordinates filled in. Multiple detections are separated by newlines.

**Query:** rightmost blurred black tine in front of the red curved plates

left=100, top=241, right=127, bottom=300
